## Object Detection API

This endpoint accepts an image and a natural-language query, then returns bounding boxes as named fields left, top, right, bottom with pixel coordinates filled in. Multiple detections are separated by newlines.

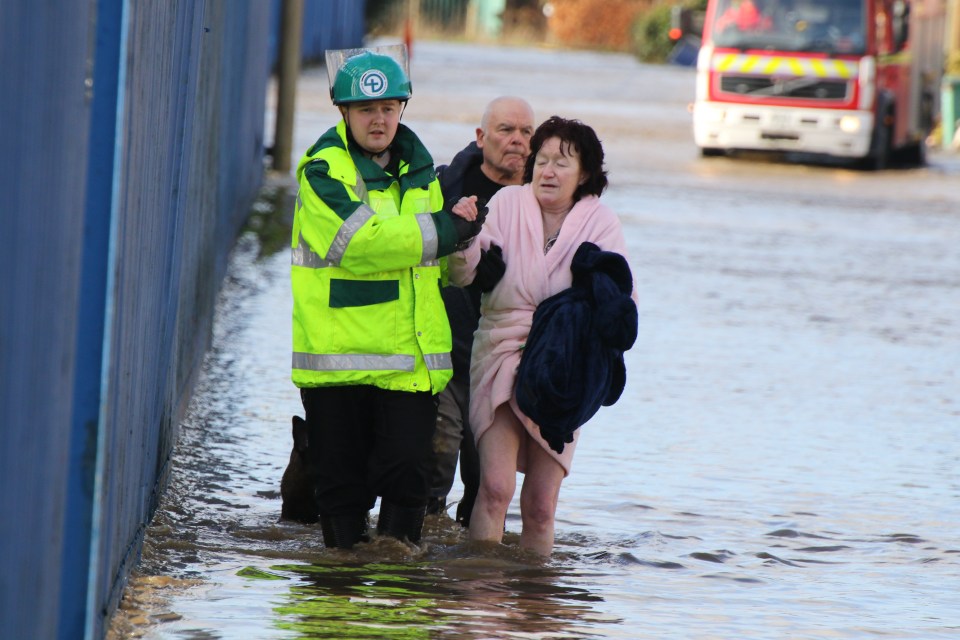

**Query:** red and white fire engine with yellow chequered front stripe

left=693, top=0, right=946, bottom=169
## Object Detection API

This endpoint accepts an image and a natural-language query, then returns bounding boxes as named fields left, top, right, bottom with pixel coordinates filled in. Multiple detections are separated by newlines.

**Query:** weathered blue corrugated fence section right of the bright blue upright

left=82, top=0, right=269, bottom=635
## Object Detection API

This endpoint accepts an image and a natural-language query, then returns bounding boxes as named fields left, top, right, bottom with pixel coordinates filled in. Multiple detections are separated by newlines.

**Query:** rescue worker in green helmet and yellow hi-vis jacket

left=290, top=45, right=483, bottom=548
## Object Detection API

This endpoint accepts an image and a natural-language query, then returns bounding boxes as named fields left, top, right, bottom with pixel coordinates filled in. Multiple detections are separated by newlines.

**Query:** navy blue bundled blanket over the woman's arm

left=516, top=242, right=637, bottom=453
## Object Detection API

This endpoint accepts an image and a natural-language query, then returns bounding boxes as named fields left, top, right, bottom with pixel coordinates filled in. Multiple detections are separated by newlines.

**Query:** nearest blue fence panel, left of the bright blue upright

left=0, top=0, right=90, bottom=638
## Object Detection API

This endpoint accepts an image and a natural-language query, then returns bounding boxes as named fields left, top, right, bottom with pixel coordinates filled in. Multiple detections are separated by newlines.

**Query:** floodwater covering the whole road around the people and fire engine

left=110, top=43, right=960, bottom=640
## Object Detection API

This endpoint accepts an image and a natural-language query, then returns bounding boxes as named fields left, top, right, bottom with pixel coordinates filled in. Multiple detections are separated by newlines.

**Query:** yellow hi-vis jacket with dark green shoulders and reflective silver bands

left=290, top=121, right=457, bottom=393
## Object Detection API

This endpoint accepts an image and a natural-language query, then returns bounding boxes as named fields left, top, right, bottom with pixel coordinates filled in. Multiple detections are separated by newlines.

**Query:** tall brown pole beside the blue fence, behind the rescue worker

left=273, top=0, right=303, bottom=173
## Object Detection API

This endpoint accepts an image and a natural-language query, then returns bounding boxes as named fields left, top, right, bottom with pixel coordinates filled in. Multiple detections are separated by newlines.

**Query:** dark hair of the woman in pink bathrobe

left=523, top=116, right=607, bottom=202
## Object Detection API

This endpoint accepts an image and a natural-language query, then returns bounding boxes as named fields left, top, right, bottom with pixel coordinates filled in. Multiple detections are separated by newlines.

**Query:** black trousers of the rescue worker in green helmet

left=300, top=385, right=437, bottom=516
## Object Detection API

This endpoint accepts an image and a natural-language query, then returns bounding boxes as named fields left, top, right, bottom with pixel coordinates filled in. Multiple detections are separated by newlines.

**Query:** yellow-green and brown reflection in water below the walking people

left=255, top=541, right=615, bottom=639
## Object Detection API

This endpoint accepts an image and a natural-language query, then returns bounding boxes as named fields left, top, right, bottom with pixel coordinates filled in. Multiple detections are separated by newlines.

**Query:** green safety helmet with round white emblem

left=330, top=51, right=412, bottom=105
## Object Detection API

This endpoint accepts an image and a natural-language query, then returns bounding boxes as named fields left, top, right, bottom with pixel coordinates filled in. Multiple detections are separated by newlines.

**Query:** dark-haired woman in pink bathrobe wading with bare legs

left=449, top=116, right=636, bottom=556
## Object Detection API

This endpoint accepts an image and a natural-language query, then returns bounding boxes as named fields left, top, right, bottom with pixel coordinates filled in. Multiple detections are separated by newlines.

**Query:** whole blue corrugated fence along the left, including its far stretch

left=0, top=0, right=364, bottom=640
